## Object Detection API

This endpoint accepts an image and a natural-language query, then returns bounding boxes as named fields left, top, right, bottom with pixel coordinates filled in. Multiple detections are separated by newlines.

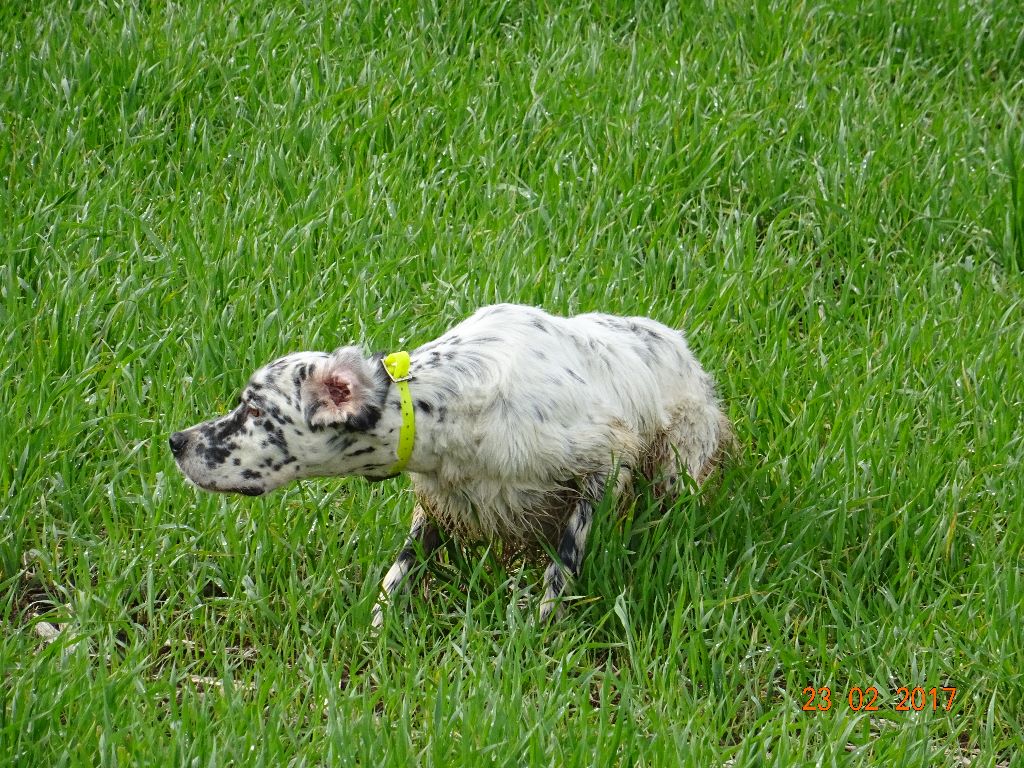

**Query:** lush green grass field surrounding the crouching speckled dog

left=0, top=0, right=1024, bottom=766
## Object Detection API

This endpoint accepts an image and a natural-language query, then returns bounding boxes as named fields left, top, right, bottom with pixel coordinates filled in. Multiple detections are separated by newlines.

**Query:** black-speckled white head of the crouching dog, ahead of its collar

left=170, top=347, right=394, bottom=496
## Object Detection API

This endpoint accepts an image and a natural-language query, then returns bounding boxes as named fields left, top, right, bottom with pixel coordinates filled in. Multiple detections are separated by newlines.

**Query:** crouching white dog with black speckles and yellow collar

left=170, top=304, right=733, bottom=627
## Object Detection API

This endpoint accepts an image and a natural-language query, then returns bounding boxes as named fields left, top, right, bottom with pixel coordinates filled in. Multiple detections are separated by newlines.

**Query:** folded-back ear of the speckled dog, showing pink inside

left=302, top=347, right=374, bottom=427
